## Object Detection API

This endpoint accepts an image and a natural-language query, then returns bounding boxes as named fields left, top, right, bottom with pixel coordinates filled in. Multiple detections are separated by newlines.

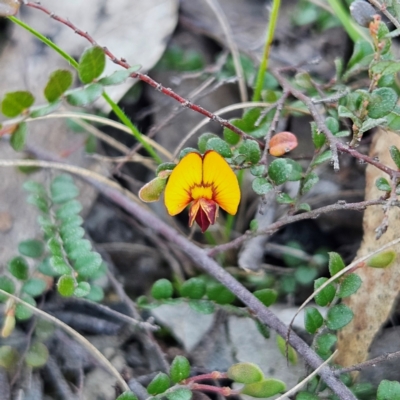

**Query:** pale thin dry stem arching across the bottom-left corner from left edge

left=0, top=289, right=129, bottom=390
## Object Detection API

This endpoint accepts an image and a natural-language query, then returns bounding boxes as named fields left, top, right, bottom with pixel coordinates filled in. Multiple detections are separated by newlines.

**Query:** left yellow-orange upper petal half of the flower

left=164, top=153, right=202, bottom=215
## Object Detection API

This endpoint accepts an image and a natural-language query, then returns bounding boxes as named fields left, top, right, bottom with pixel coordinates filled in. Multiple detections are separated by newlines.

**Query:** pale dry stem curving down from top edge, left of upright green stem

left=205, top=0, right=247, bottom=103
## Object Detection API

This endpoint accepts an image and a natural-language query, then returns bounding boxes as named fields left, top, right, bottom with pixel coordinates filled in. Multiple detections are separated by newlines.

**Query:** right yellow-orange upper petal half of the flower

left=203, top=150, right=240, bottom=215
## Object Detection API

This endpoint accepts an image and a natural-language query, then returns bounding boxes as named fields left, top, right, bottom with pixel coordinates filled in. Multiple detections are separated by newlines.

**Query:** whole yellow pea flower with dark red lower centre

left=165, top=150, right=240, bottom=232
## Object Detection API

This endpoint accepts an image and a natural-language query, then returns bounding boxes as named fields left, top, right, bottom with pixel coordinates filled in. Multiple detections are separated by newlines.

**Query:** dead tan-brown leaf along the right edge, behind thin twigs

left=335, top=129, right=400, bottom=367
